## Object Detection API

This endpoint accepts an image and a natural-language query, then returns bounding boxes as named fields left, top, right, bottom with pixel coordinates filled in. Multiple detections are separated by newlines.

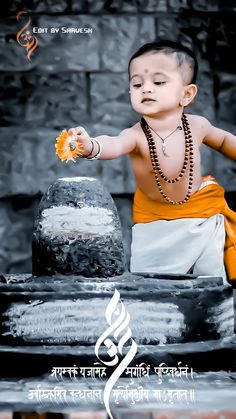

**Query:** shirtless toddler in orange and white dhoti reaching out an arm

left=66, top=41, right=236, bottom=279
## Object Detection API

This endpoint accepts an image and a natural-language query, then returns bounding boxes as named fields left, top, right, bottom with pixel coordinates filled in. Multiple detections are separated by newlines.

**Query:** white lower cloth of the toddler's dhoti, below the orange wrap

left=130, top=214, right=226, bottom=282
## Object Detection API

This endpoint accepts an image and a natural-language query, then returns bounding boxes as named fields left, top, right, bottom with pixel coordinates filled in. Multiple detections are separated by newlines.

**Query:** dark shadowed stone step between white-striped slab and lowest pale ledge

left=0, top=335, right=236, bottom=379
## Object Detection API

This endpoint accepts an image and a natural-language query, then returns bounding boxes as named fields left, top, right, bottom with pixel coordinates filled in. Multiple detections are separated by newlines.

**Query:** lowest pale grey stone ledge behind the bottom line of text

left=0, top=371, right=236, bottom=412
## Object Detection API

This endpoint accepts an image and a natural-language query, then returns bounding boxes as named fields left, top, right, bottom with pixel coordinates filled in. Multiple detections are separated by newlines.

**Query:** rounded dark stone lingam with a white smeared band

left=32, top=177, right=125, bottom=277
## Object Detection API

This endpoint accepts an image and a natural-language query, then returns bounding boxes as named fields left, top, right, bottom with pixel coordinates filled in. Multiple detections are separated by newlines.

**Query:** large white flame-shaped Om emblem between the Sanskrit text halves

left=95, top=289, right=137, bottom=419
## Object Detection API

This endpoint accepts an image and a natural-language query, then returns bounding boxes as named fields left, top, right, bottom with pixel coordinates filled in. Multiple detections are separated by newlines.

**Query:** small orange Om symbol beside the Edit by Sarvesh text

left=16, top=10, right=39, bottom=61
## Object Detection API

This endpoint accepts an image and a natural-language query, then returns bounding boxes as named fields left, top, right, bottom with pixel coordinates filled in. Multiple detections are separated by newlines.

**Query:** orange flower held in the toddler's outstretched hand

left=55, top=129, right=83, bottom=163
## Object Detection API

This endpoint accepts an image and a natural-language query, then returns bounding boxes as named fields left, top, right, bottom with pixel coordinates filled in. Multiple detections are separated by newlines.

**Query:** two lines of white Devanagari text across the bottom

left=28, top=361, right=195, bottom=408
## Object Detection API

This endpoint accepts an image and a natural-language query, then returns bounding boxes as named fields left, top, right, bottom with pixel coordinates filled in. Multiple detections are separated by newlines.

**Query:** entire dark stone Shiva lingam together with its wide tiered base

left=0, top=177, right=236, bottom=411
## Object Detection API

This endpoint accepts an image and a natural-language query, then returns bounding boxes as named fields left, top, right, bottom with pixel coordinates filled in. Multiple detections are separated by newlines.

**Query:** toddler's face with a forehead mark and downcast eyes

left=130, top=51, right=186, bottom=116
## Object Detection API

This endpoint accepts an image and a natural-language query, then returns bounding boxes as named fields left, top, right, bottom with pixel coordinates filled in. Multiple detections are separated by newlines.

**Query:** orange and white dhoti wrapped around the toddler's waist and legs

left=131, top=176, right=236, bottom=280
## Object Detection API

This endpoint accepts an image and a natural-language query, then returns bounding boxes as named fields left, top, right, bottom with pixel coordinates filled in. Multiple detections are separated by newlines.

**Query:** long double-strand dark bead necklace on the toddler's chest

left=140, top=114, right=194, bottom=205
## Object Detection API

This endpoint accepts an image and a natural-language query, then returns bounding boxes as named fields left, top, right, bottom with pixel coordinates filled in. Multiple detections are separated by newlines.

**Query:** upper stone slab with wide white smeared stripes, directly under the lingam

left=0, top=272, right=234, bottom=346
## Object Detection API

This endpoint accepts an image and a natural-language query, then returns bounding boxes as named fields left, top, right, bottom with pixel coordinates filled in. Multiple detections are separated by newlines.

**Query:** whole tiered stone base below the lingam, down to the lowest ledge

left=0, top=272, right=236, bottom=418
